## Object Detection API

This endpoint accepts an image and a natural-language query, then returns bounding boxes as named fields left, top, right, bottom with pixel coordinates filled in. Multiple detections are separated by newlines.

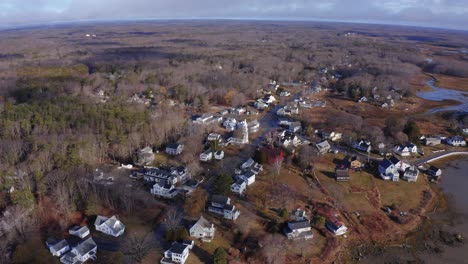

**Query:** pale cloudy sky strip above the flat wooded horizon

left=0, top=0, right=468, bottom=30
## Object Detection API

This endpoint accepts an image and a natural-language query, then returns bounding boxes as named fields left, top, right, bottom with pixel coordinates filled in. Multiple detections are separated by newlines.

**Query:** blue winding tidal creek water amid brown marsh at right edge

left=416, top=80, right=468, bottom=113
